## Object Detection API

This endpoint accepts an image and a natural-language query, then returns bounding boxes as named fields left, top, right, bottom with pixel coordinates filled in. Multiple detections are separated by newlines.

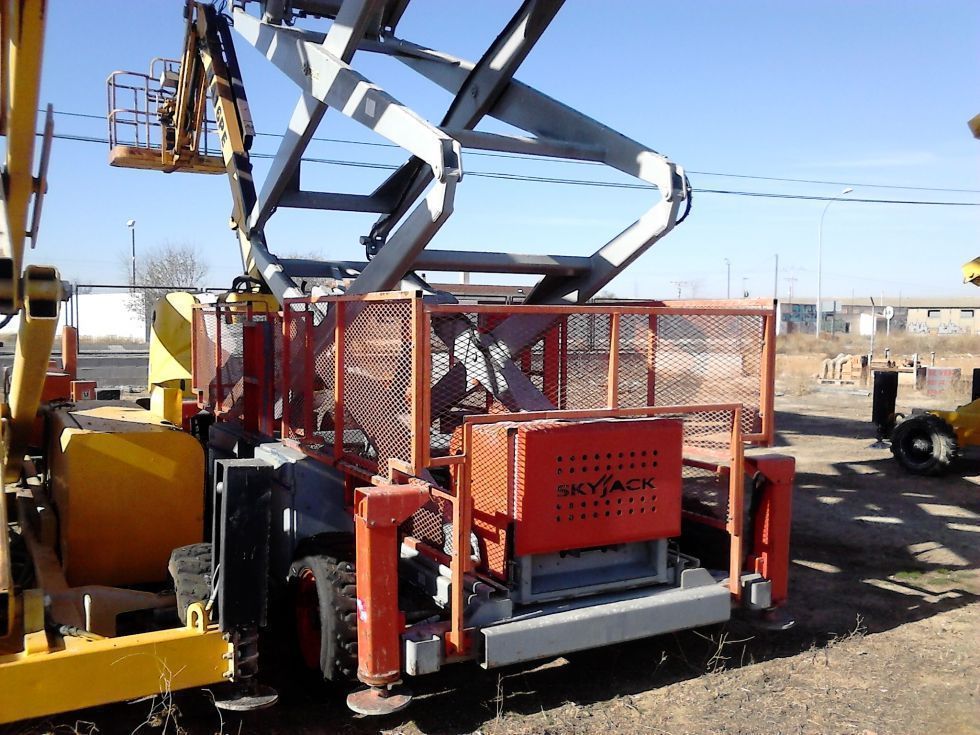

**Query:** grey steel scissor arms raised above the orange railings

left=233, top=0, right=690, bottom=304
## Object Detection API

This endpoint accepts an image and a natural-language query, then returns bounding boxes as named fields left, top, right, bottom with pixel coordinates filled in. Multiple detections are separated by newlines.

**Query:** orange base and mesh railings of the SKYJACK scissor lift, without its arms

left=194, top=292, right=793, bottom=712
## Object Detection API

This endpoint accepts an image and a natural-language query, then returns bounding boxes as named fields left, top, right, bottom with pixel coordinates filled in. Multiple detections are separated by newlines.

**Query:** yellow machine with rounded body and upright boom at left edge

left=0, top=0, right=236, bottom=723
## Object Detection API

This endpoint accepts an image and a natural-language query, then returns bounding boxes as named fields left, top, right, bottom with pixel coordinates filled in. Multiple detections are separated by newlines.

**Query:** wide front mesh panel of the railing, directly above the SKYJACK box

left=430, top=307, right=765, bottom=454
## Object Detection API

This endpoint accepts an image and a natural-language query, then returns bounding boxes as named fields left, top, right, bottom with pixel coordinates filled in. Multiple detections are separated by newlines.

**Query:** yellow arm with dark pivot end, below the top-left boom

left=0, top=265, right=61, bottom=482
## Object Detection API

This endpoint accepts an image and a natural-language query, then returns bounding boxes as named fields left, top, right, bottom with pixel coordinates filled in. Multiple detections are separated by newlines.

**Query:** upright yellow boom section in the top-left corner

left=0, top=0, right=47, bottom=314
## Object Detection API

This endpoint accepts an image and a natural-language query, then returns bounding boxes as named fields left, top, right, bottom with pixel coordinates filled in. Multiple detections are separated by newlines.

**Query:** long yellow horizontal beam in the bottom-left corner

left=0, top=604, right=233, bottom=723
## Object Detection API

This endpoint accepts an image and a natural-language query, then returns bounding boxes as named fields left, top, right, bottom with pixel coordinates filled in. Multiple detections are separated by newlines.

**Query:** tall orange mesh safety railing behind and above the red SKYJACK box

left=281, top=293, right=775, bottom=476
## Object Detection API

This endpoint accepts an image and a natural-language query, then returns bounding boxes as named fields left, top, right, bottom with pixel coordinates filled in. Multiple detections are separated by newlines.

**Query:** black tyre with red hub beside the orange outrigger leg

left=289, top=555, right=357, bottom=681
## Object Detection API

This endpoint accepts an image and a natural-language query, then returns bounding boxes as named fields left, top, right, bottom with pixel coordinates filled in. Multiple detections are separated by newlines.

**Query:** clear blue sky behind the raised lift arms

left=23, top=0, right=980, bottom=302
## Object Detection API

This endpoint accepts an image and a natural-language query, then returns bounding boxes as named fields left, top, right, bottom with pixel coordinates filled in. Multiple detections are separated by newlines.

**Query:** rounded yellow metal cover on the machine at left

left=47, top=403, right=204, bottom=586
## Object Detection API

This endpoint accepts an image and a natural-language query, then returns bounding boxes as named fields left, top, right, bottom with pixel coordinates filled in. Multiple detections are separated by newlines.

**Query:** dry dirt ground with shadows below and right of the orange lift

left=9, top=386, right=980, bottom=735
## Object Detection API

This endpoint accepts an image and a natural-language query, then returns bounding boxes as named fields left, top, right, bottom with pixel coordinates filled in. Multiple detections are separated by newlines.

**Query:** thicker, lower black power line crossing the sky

left=38, top=133, right=980, bottom=207
